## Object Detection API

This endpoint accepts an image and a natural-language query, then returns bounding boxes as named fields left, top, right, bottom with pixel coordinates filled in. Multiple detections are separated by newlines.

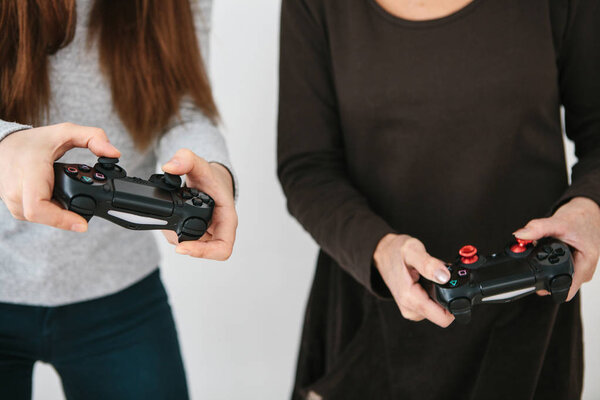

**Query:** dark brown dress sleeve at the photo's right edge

left=557, top=0, right=600, bottom=206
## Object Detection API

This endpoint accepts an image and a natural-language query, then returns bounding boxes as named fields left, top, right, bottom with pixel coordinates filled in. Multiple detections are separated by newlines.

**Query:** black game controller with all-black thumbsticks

left=53, top=157, right=215, bottom=242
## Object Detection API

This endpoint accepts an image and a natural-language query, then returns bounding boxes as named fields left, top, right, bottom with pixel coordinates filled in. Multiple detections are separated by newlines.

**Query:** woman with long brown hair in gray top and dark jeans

left=0, top=0, right=237, bottom=400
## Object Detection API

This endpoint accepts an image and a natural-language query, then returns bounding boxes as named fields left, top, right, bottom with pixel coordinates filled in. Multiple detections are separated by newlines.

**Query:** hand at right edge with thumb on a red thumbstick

left=514, top=197, right=600, bottom=301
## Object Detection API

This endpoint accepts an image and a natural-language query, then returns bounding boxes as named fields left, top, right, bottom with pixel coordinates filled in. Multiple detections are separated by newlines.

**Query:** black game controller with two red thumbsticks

left=433, top=238, right=573, bottom=323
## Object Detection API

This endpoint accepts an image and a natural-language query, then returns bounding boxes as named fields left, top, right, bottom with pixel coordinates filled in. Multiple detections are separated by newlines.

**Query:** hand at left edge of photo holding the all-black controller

left=0, top=123, right=121, bottom=232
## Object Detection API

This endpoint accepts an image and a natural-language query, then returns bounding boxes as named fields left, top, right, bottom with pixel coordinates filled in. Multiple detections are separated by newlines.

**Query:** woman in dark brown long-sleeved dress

left=279, top=0, right=600, bottom=400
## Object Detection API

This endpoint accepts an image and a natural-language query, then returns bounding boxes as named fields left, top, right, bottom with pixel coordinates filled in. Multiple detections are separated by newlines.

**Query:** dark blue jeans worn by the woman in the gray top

left=0, top=271, right=188, bottom=400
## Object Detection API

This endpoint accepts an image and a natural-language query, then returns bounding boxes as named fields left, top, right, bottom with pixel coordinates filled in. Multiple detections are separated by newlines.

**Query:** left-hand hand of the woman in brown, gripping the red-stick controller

left=373, top=234, right=454, bottom=328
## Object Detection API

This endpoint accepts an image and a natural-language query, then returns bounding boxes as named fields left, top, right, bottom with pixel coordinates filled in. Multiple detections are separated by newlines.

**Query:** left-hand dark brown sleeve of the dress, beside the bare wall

left=277, top=0, right=393, bottom=294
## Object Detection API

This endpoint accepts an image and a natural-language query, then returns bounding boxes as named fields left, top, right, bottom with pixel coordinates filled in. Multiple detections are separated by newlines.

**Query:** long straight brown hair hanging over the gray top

left=0, top=0, right=218, bottom=149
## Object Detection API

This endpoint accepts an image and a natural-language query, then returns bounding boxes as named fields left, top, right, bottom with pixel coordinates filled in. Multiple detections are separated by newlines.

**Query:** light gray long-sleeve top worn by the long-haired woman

left=0, top=0, right=231, bottom=306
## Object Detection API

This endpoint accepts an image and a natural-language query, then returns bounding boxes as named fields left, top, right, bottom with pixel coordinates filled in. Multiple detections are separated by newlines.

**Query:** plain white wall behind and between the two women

left=34, top=0, right=600, bottom=400
